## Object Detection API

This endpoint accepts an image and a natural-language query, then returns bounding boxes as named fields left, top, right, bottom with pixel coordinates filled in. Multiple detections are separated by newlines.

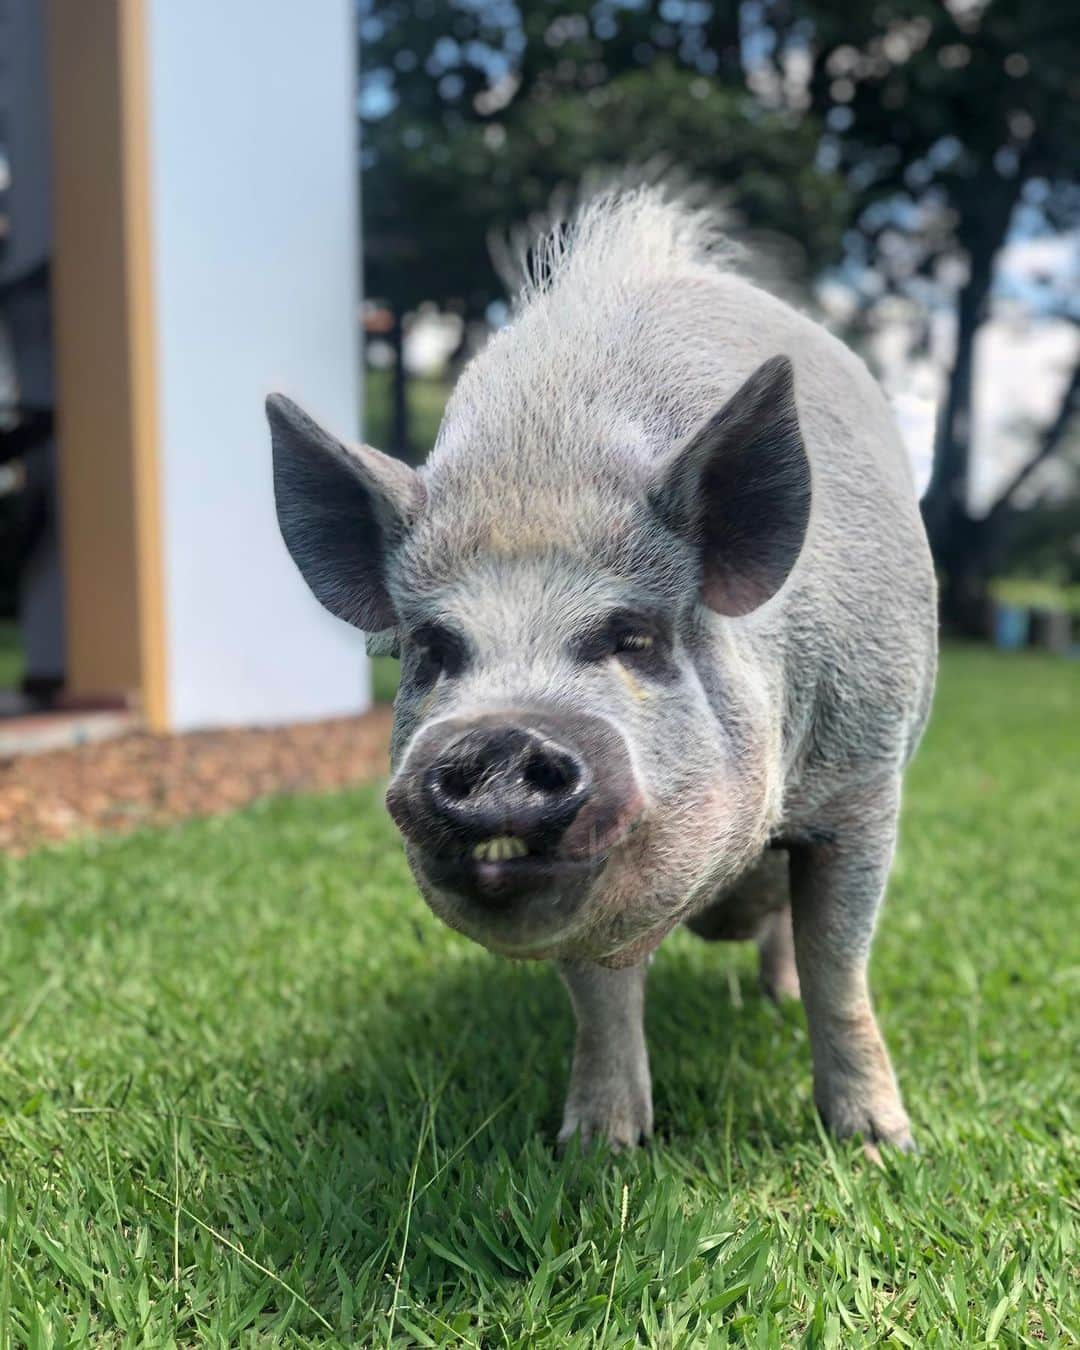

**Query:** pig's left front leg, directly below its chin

left=559, top=961, right=652, bottom=1150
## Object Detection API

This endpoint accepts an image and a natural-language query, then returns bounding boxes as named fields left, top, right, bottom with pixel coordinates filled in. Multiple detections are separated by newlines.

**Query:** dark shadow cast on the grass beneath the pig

left=259, top=937, right=818, bottom=1252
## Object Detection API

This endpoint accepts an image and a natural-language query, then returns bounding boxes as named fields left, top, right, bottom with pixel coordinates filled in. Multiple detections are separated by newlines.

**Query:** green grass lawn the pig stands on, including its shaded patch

left=0, top=651, right=1080, bottom=1347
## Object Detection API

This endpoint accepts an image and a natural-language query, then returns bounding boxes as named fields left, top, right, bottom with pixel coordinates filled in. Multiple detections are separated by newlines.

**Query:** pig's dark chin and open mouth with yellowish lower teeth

left=406, top=844, right=613, bottom=960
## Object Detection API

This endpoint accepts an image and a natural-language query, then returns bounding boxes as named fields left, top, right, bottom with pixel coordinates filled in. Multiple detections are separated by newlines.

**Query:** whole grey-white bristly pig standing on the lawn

left=267, top=186, right=937, bottom=1150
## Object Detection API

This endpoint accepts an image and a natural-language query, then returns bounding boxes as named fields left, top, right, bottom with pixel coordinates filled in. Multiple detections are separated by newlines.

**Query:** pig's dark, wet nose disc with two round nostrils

left=421, top=725, right=591, bottom=849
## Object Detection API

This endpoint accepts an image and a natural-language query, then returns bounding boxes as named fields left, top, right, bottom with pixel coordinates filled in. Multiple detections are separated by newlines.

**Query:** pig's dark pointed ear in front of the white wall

left=266, top=394, right=424, bottom=633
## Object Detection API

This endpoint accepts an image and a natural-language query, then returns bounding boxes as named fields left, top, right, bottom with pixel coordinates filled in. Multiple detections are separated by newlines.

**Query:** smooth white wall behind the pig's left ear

left=149, top=0, right=369, bottom=729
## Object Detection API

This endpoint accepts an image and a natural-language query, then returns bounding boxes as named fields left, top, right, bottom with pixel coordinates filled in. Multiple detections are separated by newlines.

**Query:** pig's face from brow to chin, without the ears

left=387, top=551, right=725, bottom=957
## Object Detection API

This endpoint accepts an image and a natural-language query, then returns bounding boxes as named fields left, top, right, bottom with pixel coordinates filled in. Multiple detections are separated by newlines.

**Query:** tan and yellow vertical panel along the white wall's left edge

left=49, top=0, right=167, bottom=728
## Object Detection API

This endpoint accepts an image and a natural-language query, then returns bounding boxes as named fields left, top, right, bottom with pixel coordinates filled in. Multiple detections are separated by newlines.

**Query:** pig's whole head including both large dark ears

left=271, top=362, right=809, bottom=964
